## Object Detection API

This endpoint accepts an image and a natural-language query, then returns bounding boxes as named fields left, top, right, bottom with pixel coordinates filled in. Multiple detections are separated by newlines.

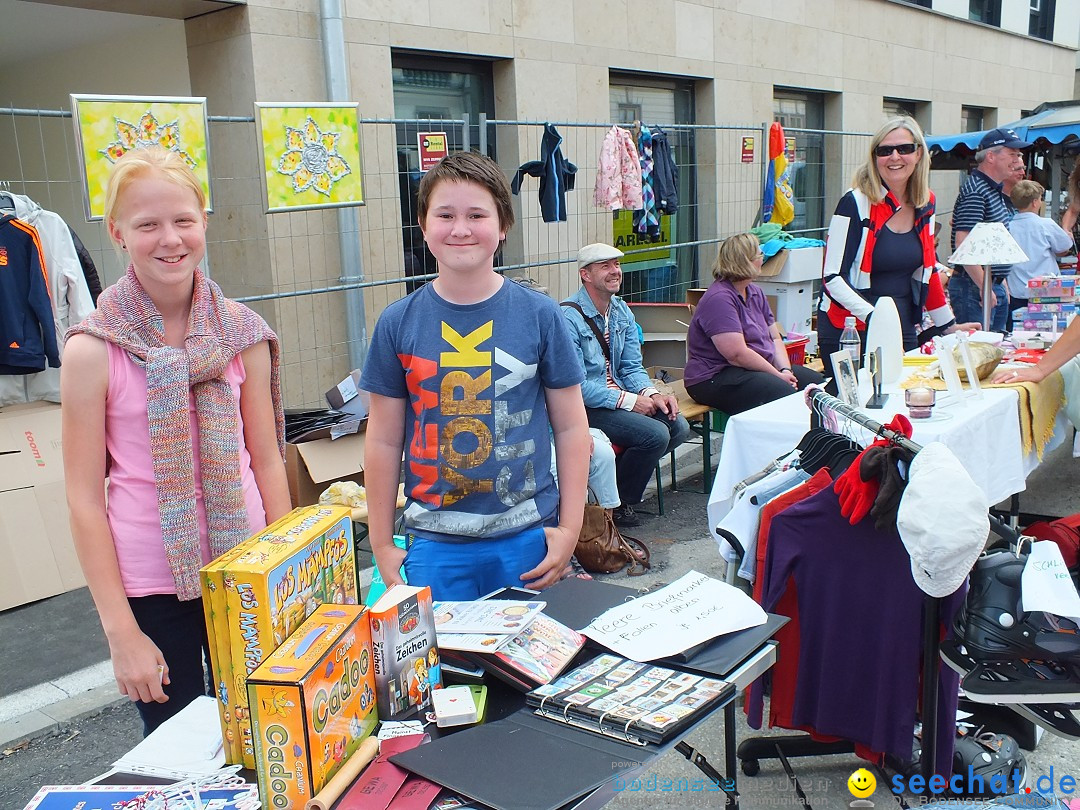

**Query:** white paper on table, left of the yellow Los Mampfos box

left=114, top=696, right=225, bottom=779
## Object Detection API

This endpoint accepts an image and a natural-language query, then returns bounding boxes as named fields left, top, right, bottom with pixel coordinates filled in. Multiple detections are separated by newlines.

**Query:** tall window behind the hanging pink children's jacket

left=608, top=73, right=698, bottom=303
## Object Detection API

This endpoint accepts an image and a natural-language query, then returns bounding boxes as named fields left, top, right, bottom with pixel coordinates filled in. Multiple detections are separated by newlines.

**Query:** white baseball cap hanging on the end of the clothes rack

left=896, top=442, right=990, bottom=596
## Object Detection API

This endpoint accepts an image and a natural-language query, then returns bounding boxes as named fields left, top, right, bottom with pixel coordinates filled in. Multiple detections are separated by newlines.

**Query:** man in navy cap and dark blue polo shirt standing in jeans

left=948, top=129, right=1031, bottom=332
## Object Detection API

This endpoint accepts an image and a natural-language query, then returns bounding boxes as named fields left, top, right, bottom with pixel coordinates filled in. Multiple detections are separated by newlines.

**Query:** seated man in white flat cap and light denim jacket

left=563, top=243, right=690, bottom=527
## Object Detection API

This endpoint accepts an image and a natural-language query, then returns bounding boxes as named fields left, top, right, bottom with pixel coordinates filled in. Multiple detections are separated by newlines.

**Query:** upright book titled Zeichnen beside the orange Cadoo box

left=369, top=584, right=443, bottom=720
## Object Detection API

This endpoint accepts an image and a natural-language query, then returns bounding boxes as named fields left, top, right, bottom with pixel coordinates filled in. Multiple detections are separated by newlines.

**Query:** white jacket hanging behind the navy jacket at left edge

left=0, top=194, right=94, bottom=407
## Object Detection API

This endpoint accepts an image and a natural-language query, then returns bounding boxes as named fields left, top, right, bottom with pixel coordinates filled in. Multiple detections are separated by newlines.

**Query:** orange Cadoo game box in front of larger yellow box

left=247, top=605, right=378, bottom=808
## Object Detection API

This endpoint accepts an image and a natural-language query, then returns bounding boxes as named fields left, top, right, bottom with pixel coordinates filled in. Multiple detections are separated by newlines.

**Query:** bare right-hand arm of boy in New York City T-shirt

left=518, top=386, right=590, bottom=590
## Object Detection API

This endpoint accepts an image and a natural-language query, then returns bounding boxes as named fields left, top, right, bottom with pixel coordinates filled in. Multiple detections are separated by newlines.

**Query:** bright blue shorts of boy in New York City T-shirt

left=405, top=526, right=548, bottom=602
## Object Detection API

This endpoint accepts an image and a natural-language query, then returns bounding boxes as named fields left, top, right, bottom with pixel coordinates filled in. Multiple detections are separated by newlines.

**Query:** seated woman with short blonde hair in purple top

left=683, top=233, right=824, bottom=414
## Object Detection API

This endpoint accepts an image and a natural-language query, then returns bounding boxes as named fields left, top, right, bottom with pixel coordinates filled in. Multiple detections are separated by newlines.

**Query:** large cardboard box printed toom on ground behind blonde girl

left=0, top=402, right=86, bottom=610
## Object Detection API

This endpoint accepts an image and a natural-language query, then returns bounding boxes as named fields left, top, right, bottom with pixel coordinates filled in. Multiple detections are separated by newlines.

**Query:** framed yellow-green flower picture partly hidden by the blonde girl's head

left=71, top=94, right=214, bottom=221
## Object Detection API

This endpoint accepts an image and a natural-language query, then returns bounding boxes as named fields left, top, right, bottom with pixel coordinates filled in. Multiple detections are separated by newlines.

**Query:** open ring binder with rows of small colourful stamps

left=525, top=654, right=735, bottom=745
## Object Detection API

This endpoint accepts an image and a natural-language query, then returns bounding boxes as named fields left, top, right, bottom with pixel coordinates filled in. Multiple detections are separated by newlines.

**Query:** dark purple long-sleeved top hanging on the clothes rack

left=761, top=487, right=968, bottom=778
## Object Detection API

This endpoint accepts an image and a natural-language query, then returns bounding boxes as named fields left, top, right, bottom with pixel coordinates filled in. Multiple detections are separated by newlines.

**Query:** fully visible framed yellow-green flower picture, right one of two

left=255, top=102, right=364, bottom=214
